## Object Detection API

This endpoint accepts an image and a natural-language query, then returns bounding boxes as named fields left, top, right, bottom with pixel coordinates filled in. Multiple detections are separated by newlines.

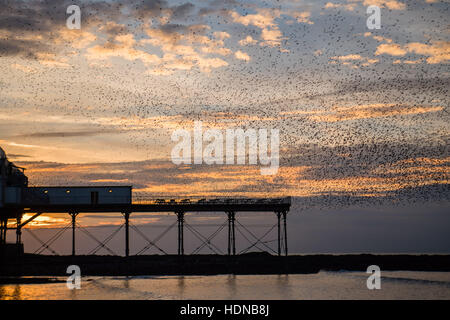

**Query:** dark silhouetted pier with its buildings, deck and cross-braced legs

left=0, top=149, right=291, bottom=257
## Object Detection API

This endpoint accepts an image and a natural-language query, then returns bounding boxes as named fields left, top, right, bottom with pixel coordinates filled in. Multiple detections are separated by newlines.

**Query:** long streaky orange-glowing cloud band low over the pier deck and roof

left=12, top=143, right=450, bottom=206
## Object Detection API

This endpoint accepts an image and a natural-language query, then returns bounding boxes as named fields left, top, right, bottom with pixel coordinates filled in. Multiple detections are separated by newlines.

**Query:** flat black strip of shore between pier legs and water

left=0, top=252, right=450, bottom=278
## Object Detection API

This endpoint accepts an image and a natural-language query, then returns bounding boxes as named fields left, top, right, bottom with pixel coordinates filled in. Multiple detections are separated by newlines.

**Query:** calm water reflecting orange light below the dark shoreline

left=0, top=271, right=450, bottom=300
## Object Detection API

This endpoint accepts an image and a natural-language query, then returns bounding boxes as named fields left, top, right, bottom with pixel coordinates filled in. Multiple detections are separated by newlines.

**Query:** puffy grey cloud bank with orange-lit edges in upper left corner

left=0, top=0, right=232, bottom=72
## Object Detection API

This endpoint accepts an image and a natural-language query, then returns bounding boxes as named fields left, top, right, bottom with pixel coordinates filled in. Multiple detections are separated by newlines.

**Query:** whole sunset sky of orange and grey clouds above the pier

left=0, top=0, right=450, bottom=232
